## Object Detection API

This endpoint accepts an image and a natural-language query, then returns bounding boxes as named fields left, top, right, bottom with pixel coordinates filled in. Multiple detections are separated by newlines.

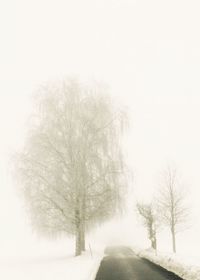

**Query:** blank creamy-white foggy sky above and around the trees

left=0, top=0, right=200, bottom=258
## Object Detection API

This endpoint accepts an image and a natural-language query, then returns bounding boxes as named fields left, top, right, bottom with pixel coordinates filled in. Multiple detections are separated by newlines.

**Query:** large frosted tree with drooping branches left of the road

left=17, top=80, right=125, bottom=255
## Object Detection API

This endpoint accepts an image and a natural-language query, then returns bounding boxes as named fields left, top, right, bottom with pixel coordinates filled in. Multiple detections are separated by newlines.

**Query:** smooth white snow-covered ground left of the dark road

left=0, top=254, right=101, bottom=280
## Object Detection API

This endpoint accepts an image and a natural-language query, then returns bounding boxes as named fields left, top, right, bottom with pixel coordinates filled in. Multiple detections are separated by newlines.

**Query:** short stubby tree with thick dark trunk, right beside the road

left=136, top=203, right=157, bottom=250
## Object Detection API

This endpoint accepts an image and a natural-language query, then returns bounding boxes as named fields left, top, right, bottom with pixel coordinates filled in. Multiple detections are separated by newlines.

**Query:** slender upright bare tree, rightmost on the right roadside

left=158, top=167, right=188, bottom=253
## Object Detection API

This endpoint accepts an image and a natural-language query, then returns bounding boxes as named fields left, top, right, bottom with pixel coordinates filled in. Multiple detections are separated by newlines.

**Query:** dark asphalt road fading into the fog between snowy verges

left=96, top=247, right=183, bottom=280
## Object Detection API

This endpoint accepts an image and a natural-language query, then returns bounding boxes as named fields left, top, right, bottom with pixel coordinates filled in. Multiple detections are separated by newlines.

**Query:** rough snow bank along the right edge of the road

left=133, top=248, right=200, bottom=280
